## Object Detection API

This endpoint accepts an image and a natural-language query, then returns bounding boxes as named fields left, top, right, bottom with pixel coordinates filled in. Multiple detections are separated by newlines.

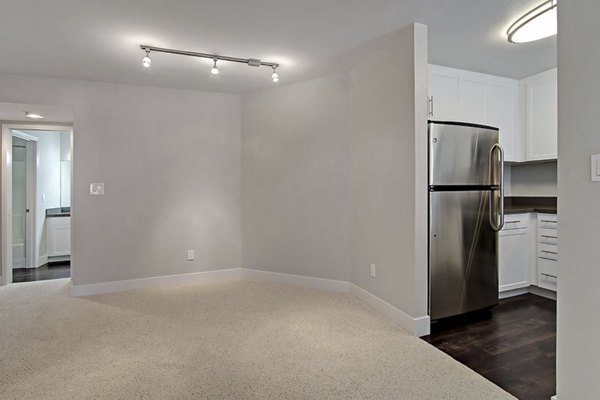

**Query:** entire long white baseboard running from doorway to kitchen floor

left=71, top=268, right=430, bottom=336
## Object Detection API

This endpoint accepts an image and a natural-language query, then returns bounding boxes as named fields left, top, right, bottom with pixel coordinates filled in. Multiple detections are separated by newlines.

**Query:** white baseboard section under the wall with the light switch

left=71, top=268, right=241, bottom=297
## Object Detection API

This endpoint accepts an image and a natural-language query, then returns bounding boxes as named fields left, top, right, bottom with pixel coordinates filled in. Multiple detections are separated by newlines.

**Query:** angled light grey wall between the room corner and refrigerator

left=242, top=25, right=427, bottom=332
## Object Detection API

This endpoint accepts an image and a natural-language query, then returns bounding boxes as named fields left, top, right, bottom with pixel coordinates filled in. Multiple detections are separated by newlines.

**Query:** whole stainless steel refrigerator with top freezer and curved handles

left=428, top=121, right=504, bottom=320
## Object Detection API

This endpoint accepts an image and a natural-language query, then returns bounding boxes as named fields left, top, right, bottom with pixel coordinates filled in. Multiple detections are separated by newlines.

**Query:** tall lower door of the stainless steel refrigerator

left=429, top=191, right=498, bottom=320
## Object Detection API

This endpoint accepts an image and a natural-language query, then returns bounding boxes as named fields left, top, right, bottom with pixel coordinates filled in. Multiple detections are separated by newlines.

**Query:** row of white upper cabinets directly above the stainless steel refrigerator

left=429, top=65, right=525, bottom=161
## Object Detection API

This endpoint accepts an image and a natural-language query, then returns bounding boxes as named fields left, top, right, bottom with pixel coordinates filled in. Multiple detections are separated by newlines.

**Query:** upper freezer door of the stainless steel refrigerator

left=429, top=122, right=500, bottom=186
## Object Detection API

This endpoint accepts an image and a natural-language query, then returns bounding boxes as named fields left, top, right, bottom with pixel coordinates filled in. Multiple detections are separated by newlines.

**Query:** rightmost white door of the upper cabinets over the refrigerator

left=486, top=85, right=520, bottom=161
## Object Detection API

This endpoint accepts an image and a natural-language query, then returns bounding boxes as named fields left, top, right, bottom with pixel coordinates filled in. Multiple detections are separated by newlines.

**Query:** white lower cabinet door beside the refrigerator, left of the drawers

left=498, top=229, right=530, bottom=292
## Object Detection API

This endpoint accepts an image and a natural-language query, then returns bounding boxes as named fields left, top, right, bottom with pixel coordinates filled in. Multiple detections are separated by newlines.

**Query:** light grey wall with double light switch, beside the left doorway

left=0, top=75, right=241, bottom=285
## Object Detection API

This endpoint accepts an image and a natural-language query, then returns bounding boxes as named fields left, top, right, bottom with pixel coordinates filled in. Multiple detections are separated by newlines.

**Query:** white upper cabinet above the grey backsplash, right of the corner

left=521, top=69, right=558, bottom=161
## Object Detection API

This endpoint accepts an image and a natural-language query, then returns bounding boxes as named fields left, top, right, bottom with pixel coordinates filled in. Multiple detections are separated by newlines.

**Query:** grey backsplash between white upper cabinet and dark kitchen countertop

left=505, top=161, right=558, bottom=197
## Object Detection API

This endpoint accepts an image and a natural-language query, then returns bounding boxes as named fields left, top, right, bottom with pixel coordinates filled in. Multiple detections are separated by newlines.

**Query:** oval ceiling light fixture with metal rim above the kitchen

left=506, top=0, right=558, bottom=44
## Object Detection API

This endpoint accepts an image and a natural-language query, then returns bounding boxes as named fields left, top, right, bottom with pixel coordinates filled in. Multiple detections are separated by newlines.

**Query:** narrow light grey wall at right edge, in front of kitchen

left=557, top=0, right=600, bottom=400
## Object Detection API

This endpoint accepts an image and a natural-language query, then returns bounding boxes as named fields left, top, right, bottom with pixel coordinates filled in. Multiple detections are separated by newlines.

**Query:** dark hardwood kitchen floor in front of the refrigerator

left=423, top=294, right=556, bottom=400
